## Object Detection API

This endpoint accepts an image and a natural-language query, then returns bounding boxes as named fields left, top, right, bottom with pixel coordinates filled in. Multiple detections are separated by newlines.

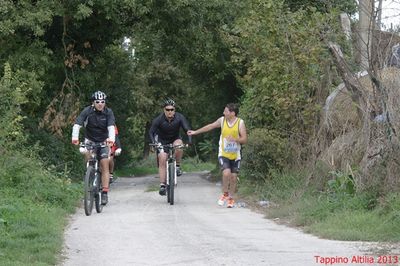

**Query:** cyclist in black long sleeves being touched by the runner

left=149, top=99, right=192, bottom=196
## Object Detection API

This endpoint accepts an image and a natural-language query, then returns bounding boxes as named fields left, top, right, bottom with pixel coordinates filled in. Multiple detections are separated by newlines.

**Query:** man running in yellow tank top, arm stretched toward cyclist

left=187, top=103, right=247, bottom=208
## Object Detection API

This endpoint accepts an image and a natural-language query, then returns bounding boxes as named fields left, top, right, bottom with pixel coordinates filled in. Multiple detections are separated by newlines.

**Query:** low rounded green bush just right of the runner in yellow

left=242, top=128, right=290, bottom=180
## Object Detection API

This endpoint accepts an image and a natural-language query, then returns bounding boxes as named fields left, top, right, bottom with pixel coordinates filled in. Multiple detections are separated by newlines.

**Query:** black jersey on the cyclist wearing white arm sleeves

left=75, top=106, right=115, bottom=142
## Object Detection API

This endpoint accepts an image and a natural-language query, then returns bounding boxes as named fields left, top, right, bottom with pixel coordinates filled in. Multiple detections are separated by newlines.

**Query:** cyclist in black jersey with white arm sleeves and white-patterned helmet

left=72, top=91, right=115, bottom=205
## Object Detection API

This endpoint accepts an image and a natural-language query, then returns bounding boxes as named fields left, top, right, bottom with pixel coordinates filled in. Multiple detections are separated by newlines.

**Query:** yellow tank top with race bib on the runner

left=218, top=118, right=240, bottom=160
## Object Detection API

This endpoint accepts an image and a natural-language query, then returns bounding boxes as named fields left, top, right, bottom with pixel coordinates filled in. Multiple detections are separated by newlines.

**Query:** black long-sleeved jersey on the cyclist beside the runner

left=149, top=112, right=192, bottom=144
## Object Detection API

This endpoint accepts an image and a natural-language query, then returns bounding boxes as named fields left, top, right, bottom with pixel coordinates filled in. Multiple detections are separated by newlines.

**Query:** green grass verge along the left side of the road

left=0, top=153, right=82, bottom=265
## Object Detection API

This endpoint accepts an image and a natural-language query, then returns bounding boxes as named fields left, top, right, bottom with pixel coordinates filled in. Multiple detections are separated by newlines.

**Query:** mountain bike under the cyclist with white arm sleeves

left=79, top=142, right=107, bottom=216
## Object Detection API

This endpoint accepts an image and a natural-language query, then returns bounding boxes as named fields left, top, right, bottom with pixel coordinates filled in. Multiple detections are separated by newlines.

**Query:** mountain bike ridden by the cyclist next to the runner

left=150, top=143, right=188, bottom=205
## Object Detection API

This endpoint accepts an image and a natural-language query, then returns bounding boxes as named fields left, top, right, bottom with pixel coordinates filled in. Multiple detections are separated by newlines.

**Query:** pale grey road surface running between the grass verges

left=61, top=171, right=377, bottom=266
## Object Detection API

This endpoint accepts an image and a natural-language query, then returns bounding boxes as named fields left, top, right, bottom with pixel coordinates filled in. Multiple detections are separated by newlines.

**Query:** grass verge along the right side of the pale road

left=239, top=169, right=400, bottom=242
